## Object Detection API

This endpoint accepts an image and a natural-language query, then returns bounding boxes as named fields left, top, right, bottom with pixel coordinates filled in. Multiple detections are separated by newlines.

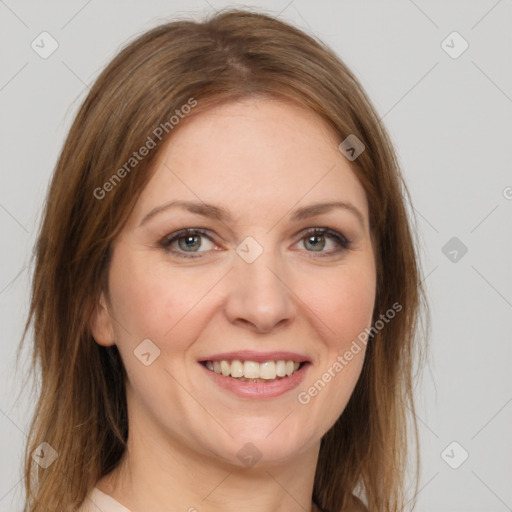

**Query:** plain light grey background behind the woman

left=0, top=0, right=512, bottom=512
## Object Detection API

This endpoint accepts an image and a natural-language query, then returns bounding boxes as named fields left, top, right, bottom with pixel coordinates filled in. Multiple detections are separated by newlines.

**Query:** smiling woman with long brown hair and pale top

left=21, top=10, right=424, bottom=512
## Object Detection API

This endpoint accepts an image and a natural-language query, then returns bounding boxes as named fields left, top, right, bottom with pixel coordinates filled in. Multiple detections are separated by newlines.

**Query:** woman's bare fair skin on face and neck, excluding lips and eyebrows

left=91, top=98, right=376, bottom=512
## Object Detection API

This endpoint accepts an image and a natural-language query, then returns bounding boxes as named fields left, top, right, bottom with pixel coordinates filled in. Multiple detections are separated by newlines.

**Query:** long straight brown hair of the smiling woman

left=23, top=10, right=426, bottom=512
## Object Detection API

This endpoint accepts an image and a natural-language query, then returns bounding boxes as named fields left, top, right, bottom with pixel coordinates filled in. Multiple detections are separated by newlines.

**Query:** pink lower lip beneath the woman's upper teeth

left=199, top=363, right=311, bottom=399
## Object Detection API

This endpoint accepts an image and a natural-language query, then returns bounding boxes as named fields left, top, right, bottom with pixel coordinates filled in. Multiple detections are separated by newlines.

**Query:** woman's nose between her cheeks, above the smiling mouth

left=224, top=247, right=296, bottom=333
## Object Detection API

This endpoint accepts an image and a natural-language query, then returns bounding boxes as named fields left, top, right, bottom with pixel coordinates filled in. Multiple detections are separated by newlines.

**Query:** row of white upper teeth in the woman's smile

left=206, top=359, right=300, bottom=380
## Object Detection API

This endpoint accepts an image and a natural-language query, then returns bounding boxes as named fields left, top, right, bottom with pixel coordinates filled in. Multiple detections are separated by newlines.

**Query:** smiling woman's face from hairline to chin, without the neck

left=92, top=99, right=376, bottom=466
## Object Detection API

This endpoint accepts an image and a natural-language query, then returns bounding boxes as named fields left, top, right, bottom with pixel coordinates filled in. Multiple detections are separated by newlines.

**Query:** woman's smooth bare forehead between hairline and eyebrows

left=128, top=98, right=367, bottom=227
